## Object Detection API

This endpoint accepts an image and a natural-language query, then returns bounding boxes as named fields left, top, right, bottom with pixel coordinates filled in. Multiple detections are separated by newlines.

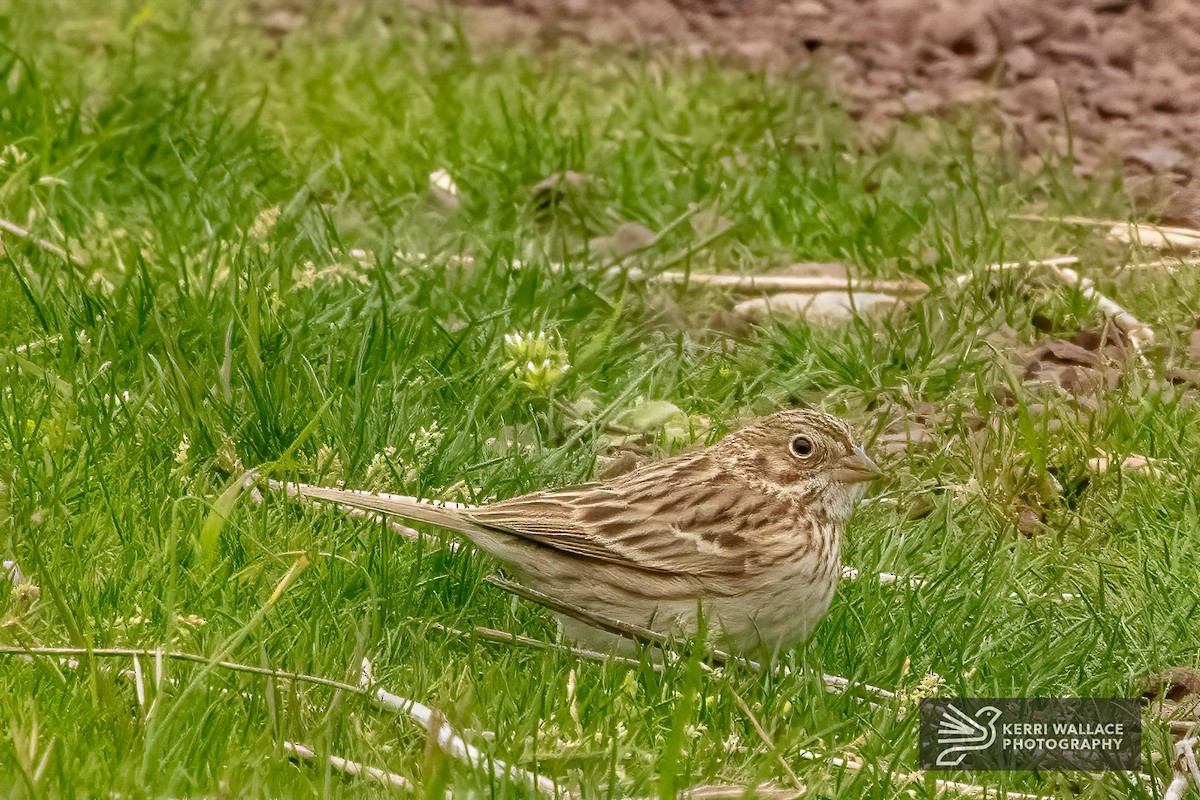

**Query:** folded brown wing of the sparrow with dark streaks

left=463, top=457, right=754, bottom=578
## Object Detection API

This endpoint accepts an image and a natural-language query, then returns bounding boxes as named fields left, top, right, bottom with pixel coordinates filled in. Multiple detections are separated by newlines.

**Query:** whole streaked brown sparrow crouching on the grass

left=282, top=410, right=878, bottom=655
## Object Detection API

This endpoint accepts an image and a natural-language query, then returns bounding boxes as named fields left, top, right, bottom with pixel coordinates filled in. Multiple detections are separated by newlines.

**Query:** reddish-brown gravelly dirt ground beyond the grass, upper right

left=441, top=0, right=1200, bottom=227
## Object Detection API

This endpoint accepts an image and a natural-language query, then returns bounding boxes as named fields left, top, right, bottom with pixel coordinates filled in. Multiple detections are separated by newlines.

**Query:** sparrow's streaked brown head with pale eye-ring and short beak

left=718, top=409, right=881, bottom=517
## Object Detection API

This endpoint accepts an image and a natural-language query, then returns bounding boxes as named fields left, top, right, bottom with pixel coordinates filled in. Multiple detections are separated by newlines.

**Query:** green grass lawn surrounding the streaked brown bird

left=0, top=0, right=1200, bottom=798
